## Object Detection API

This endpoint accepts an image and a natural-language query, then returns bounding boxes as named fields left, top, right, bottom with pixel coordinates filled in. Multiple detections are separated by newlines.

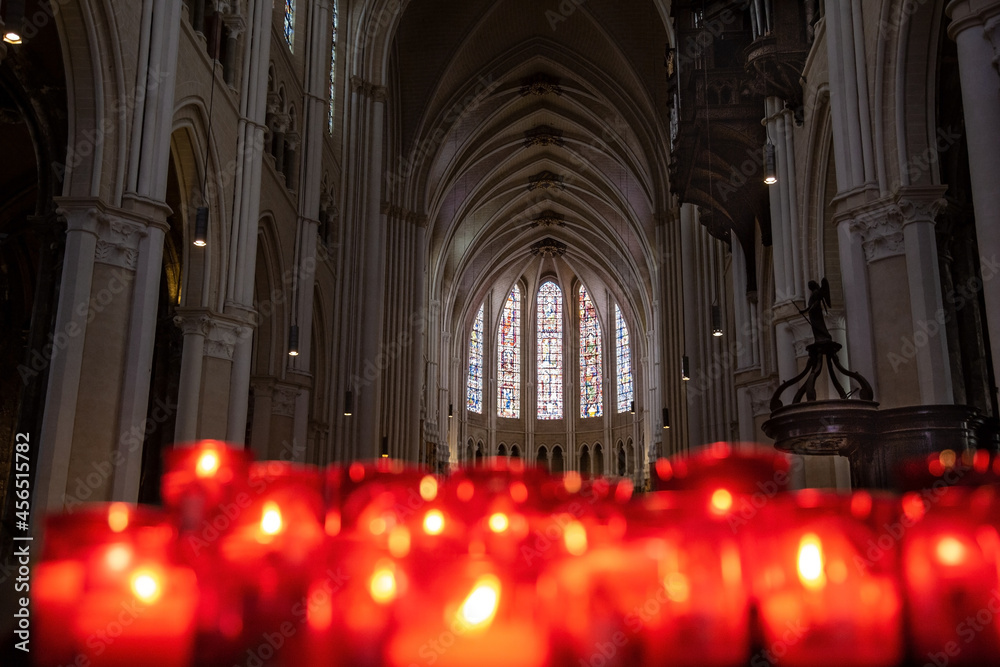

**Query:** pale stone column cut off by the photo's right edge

left=946, top=0, right=1000, bottom=402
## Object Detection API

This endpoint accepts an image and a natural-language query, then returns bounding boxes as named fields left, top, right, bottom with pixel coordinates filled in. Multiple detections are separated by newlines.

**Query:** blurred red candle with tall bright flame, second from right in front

left=755, top=492, right=904, bottom=667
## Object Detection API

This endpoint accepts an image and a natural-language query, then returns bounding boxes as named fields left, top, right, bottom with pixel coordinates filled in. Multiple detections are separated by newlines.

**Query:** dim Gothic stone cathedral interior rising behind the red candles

left=0, top=0, right=1000, bottom=664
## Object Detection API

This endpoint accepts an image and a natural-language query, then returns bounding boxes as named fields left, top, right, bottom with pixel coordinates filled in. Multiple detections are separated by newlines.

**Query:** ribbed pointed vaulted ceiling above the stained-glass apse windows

left=388, top=0, right=669, bottom=340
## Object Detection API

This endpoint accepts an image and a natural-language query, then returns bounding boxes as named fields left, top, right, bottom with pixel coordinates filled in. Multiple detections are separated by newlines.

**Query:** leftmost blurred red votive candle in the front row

left=34, top=503, right=198, bottom=667
